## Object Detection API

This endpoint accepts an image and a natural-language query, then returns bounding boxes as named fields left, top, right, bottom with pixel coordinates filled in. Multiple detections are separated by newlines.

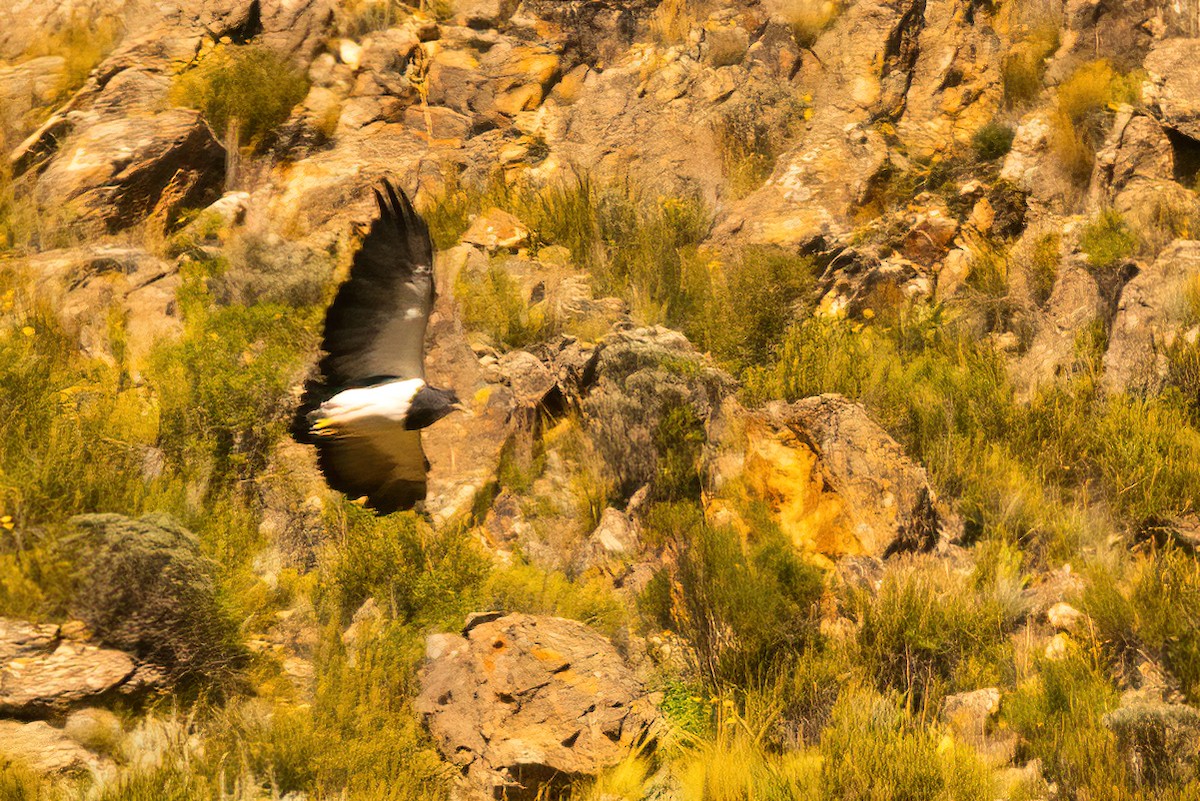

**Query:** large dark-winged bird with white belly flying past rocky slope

left=293, top=180, right=462, bottom=514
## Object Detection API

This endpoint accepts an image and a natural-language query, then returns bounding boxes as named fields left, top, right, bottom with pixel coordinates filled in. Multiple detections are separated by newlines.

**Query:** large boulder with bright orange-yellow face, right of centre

left=708, top=395, right=954, bottom=558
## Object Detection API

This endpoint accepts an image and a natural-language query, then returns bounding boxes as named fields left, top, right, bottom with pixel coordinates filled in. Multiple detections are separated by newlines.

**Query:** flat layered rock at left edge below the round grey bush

left=0, top=618, right=136, bottom=714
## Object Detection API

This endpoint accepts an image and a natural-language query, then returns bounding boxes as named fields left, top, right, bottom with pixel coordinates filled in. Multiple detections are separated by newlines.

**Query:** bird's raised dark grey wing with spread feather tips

left=320, top=181, right=433, bottom=386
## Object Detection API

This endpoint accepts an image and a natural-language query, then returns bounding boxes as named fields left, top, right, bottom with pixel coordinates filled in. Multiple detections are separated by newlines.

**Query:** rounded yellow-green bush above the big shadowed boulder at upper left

left=170, top=44, right=308, bottom=147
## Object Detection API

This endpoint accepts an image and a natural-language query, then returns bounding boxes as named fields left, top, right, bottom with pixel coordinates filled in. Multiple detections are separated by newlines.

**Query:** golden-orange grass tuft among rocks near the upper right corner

left=1050, top=60, right=1140, bottom=185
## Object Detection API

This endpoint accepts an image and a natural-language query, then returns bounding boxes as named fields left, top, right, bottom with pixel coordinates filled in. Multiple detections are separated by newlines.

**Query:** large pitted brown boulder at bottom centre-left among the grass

left=418, top=614, right=655, bottom=799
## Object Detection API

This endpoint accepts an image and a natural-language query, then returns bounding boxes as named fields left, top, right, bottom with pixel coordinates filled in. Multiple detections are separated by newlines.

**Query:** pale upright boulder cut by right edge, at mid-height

left=1103, top=241, right=1200, bottom=392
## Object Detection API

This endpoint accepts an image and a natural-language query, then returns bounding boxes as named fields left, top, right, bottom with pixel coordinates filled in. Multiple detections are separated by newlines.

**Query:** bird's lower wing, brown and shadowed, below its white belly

left=316, top=426, right=428, bottom=514
